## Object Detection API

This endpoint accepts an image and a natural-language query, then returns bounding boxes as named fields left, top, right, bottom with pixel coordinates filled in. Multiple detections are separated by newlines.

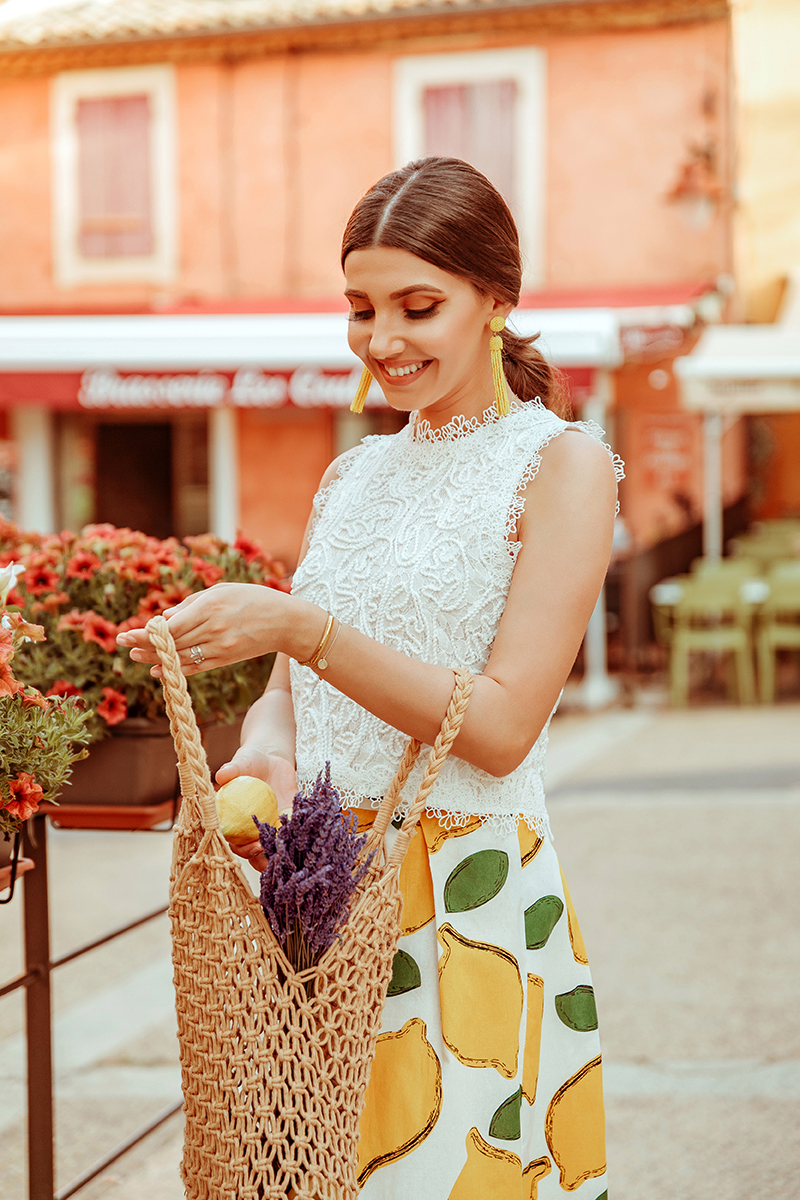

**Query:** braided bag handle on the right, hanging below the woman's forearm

left=367, top=667, right=475, bottom=870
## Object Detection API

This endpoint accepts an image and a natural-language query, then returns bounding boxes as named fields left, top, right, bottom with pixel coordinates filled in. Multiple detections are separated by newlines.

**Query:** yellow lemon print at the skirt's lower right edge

left=545, top=1057, right=606, bottom=1192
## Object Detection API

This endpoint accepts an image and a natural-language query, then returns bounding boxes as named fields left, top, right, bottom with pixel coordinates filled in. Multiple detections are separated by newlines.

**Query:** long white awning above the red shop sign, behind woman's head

left=0, top=308, right=621, bottom=372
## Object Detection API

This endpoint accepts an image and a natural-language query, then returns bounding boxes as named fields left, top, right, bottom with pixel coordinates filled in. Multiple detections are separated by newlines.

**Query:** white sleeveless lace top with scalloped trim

left=290, top=402, right=621, bottom=834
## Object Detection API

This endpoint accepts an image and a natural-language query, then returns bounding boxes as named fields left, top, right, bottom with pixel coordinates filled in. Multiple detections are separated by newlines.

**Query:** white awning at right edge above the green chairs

left=674, top=325, right=800, bottom=414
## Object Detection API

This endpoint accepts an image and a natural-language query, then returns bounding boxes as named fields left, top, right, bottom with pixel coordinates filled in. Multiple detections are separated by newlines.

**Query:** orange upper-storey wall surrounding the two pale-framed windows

left=0, top=20, right=729, bottom=308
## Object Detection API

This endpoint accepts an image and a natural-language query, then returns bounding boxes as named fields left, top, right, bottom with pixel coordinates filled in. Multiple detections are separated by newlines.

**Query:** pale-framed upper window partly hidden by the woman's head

left=395, top=48, right=546, bottom=288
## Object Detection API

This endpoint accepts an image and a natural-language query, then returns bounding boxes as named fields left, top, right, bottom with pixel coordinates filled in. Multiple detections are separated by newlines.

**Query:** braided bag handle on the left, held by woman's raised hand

left=145, top=617, right=219, bottom=830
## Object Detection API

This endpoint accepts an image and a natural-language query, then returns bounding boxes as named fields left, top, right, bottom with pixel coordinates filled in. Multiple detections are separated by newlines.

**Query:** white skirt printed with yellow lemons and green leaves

left=359, top=811, right=607, bottom=1200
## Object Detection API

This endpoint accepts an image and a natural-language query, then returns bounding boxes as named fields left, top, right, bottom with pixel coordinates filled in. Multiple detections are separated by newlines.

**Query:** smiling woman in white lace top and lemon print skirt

left=119, top=158, right=615, bottom=1200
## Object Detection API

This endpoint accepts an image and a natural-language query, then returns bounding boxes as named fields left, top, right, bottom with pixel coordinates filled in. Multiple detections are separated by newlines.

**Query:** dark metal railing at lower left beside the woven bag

left=0, top=815, right=184, bottom=1200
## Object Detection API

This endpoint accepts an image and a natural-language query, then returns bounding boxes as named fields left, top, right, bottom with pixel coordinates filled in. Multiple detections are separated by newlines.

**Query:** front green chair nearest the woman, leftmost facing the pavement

left=669, top=575, right=763, bottom=708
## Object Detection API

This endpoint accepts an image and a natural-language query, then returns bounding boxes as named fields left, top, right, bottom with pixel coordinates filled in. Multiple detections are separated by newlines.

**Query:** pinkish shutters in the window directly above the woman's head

left=422, top=79, right=517, bottom=208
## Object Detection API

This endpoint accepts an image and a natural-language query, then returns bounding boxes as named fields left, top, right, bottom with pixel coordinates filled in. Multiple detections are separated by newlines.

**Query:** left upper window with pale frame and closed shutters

left=53, top=66, right=175, bottom=287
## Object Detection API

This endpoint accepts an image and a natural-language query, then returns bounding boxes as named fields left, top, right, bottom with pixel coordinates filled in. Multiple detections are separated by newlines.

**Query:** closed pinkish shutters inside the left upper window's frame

left=76, top=96, right=154, bottom=258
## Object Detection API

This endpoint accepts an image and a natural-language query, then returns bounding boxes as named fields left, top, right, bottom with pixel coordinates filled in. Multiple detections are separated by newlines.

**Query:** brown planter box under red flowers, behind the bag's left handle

left=57, top=716, right=242, bottom=824
